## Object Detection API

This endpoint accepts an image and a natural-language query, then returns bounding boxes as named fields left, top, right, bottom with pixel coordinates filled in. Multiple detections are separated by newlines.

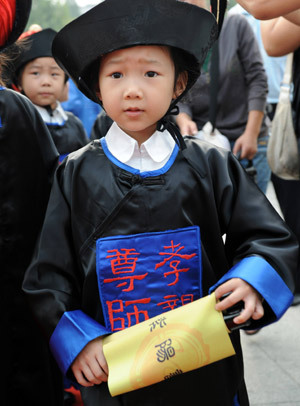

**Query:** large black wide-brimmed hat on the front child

left=52, top=0, right=218, bottom=102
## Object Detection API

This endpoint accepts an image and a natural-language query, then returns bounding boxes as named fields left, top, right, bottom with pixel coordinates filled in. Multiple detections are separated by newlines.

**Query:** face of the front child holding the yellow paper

left=98, top=45, right=185, bottom=144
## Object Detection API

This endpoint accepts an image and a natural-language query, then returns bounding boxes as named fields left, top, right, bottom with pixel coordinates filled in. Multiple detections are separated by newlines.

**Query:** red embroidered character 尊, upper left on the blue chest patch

left=103, top=248, right=148, bottom=292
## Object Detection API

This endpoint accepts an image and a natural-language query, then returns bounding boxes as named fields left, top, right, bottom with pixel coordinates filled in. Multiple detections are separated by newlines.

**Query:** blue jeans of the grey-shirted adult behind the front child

left=230, top=135, right=271, bottom=193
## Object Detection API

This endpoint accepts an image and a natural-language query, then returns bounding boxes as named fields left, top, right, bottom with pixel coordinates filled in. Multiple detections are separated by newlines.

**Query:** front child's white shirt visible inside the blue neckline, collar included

left=105, top=123, right=175, bottom=172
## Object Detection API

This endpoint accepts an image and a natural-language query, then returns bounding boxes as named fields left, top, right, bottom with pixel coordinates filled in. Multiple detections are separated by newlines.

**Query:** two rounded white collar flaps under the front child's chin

left=105, top=122, right=175, bottom=163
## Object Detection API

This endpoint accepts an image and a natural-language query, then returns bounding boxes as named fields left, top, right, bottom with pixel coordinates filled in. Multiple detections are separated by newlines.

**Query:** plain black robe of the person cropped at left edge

left=0, top=88, right=63, bottom=406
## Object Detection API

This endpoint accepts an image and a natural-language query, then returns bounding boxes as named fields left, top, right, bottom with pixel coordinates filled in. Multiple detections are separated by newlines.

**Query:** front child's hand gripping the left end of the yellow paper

left=71, top=337, right=108, bottom=387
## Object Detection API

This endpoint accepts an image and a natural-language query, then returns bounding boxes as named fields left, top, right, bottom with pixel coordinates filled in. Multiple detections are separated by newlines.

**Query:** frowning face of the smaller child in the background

left=19, top=57, right=65, bottom=109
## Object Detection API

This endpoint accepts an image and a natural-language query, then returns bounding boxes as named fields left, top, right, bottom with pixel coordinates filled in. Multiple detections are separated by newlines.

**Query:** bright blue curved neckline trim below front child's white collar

left=100, top=138, right=179, bottom=178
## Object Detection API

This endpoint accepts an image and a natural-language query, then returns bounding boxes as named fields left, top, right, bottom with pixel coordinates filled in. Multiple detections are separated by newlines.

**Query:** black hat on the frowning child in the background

left=14, top=28, right=56, bottom=72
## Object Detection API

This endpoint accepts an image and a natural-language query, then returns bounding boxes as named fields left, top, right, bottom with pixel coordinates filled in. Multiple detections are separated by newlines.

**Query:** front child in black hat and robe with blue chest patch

left=23, top=0, right=297, bottom=406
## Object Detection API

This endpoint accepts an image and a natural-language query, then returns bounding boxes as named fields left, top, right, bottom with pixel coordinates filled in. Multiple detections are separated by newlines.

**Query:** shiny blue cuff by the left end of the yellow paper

left=50, top=310, right=109, bottom=374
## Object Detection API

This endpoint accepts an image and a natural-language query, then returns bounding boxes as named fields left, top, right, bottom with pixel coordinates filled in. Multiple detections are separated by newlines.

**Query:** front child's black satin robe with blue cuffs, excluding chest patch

left=23, top=137, right=298, bottom=406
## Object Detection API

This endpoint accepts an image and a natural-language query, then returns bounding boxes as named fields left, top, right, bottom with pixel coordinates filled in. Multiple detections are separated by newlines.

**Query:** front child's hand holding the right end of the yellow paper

left=215, top=278, right=264, bottom=324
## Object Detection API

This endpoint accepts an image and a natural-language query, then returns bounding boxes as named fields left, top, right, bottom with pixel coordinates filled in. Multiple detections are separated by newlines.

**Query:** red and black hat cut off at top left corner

left=0, top=0, right=31, bottom=52
